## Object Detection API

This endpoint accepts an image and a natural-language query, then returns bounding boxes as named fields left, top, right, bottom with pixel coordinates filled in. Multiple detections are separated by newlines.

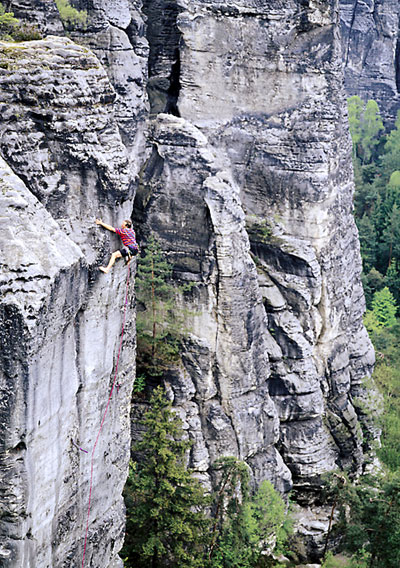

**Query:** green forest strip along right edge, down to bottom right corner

left=323, top=96, right=400, bottom=568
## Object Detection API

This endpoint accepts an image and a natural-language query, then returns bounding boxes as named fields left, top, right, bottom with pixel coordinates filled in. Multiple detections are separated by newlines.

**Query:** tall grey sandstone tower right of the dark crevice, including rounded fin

left=136, top=1, right=373, bottom=499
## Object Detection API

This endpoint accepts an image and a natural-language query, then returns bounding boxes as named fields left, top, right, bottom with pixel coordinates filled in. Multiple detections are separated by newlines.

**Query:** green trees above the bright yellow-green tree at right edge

left=348, top=96, right=400, bottom=302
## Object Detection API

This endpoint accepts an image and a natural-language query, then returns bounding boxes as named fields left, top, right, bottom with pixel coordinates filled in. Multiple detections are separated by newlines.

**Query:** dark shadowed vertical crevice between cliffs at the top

left=143, top=0, right=182, bottom=116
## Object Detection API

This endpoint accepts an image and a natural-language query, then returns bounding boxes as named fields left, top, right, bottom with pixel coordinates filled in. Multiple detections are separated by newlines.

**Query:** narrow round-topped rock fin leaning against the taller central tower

left=135, top=114, right=290, bottom=490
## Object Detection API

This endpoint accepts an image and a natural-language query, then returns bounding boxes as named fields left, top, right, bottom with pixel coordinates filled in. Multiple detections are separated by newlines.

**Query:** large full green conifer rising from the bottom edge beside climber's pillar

left=122, top=387, right=209, bottom=568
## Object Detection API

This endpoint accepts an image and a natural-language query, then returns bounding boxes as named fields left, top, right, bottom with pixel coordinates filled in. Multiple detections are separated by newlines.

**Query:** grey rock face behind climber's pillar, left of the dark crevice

left=9, top=0, right=149, bottom=171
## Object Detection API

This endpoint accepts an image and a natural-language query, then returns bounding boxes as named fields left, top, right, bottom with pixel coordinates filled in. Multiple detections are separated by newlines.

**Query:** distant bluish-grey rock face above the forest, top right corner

left=340, top=0, right=400, bottom=124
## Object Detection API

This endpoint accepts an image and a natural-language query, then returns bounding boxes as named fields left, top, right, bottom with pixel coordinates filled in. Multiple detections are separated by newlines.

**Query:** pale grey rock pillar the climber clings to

left=0, top=37, right=138, bottom=568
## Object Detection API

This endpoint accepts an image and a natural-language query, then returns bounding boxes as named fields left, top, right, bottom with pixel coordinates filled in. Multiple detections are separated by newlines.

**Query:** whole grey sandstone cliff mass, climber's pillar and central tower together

left=0, top=0, right=374, bottom=568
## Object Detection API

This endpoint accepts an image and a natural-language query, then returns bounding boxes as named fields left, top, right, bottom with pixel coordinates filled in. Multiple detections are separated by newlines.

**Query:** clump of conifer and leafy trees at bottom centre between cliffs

left=122, top=387, right=290, bottom=568
